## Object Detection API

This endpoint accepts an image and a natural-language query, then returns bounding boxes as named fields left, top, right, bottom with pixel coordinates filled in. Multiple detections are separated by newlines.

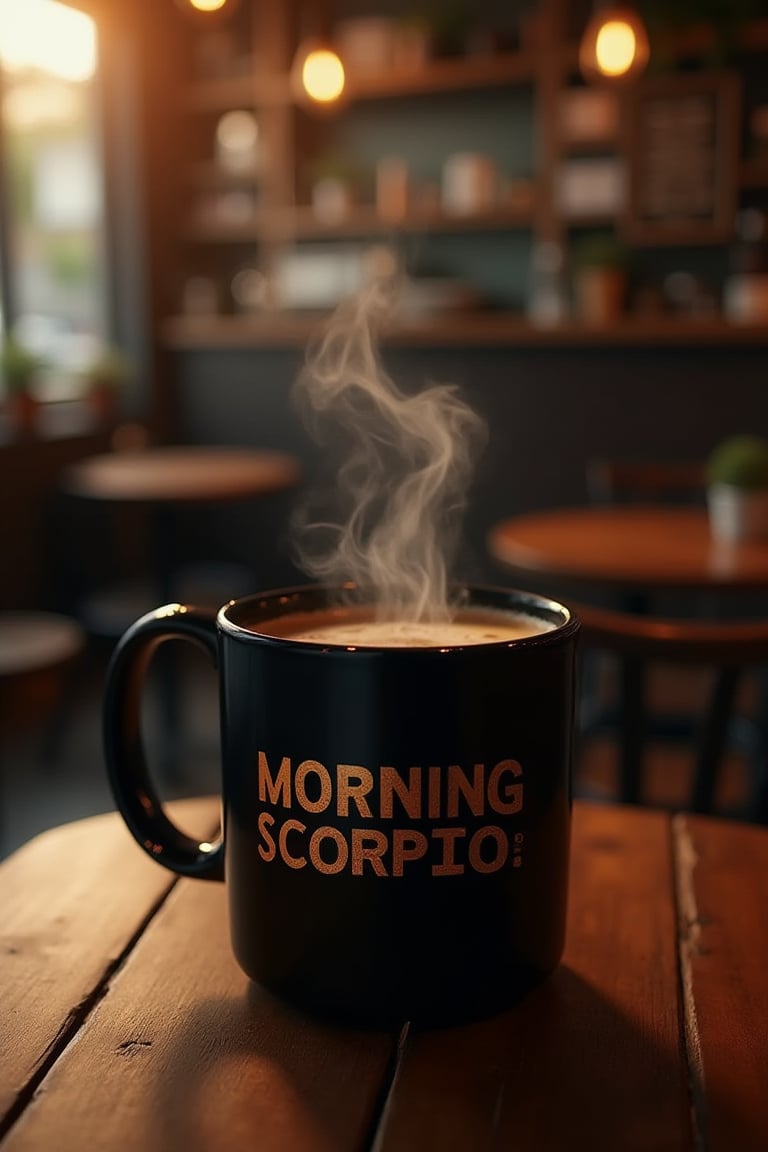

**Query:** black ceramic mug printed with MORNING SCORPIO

left=105, top=586, right=578, bottom=1026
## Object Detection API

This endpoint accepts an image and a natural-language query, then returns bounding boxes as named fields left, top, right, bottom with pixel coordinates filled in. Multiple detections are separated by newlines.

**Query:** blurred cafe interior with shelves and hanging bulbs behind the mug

left=0, top=0, right=768, bottom=855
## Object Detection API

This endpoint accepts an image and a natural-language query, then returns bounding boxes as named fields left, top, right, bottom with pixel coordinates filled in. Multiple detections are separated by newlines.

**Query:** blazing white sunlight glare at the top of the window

left=0, top=0, right=97, bottom=81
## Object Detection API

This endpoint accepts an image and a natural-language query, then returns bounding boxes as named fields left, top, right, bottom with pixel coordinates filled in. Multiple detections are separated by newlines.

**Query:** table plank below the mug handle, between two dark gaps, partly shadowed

left=2, top=880, right=400, bottom=1152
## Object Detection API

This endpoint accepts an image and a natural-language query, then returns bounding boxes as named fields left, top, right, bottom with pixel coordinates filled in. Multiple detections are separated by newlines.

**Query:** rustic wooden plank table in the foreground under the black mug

left=0, top=801, right=768, bottom=1152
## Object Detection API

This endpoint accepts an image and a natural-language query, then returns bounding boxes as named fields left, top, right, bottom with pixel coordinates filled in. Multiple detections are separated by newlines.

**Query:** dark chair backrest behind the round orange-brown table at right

left=586, top=458, right=706, bottom=505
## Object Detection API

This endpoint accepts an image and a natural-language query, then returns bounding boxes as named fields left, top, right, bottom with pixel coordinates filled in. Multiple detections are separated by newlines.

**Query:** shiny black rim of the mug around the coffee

left=216, top=581, right=579, bottom=659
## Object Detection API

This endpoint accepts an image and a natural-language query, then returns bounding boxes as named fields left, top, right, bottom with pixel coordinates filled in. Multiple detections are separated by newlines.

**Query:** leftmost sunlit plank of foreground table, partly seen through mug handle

left=0, top=799, right=219, bottom=1132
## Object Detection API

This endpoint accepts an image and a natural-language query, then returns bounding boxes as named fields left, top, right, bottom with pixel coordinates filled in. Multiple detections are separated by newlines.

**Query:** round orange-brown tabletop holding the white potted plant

left=488, top=505, right=768, bottom=592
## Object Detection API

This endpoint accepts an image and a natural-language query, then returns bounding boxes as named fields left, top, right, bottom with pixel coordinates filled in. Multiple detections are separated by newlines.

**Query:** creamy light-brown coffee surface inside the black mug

left=252, top=608, right=555, bottom=647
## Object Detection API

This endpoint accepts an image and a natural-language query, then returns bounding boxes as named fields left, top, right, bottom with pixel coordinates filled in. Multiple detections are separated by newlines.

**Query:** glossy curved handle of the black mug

left=102, top=604, right=225, bottom=880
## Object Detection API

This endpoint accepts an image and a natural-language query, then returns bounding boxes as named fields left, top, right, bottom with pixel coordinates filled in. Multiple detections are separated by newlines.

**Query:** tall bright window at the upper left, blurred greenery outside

left=0, top=0, right=108, bottom=399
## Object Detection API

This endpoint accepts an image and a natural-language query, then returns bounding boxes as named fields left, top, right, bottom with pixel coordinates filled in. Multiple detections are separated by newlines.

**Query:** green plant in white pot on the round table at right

left=707, top=434, right=768, bottom=541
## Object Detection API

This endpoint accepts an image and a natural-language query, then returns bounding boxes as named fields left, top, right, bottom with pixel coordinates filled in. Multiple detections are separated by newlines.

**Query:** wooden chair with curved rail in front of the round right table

left=570, top=602, right=768, bottom=821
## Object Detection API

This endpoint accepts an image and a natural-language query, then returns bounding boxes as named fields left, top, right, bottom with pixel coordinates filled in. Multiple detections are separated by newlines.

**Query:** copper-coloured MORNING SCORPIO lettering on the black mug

left=258, top=751, right=523, bottom=877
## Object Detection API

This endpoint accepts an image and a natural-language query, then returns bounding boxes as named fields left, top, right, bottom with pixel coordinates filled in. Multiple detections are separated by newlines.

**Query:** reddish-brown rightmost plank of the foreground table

left=674, top=817, right=768, bottom=1152
